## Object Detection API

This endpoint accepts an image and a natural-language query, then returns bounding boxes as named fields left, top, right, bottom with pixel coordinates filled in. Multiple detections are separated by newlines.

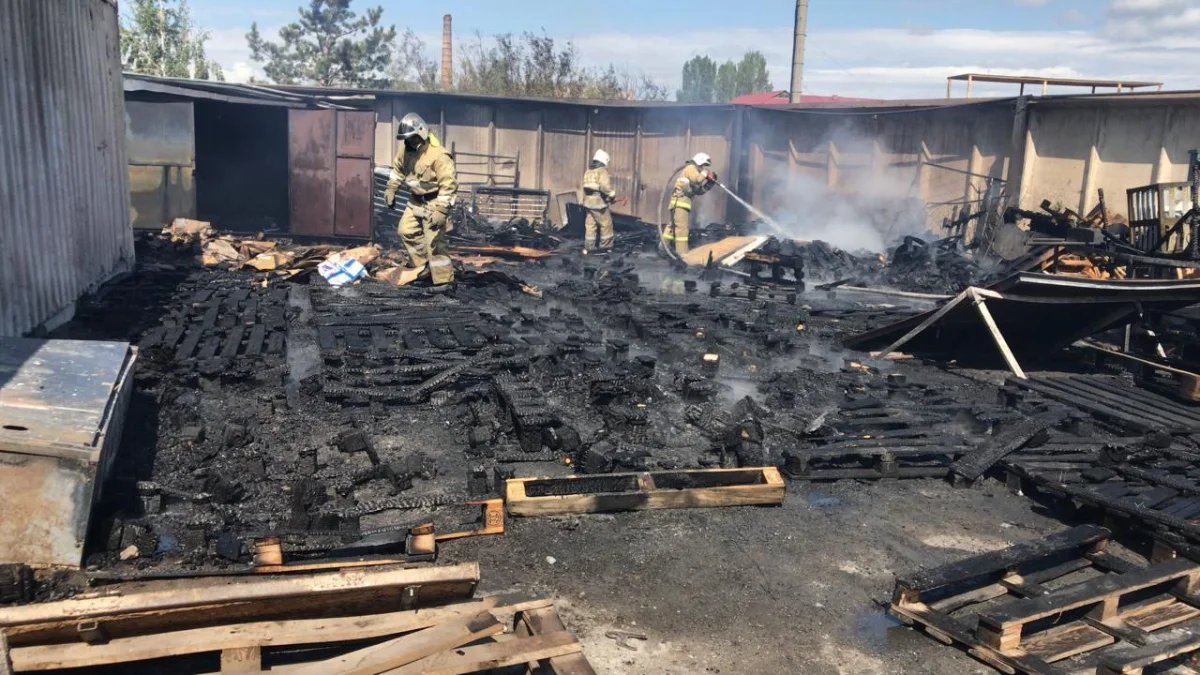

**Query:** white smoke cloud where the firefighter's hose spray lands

left=757, top=121, right=929, bottom=252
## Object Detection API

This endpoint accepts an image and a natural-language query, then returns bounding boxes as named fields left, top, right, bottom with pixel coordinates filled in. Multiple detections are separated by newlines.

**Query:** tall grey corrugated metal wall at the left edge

left=0, top=0, right=133, bottom=335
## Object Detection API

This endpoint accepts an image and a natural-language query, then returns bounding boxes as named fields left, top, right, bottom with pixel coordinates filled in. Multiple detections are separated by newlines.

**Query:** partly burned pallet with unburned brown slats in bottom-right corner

left=889, top=525, right=1200, bottom=675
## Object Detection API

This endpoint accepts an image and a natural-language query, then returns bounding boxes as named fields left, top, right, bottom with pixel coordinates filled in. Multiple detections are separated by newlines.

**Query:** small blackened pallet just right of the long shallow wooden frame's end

left=784, top=441, right=970, bottom=480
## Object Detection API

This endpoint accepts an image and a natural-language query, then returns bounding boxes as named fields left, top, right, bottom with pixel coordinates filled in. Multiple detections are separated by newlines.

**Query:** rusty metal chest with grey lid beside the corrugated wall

left=0, top=339, right=137, bottom=567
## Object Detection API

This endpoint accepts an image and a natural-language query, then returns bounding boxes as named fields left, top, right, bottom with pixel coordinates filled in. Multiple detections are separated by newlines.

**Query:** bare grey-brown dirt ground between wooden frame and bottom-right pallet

left=444, top=480, right=1063, bottom=675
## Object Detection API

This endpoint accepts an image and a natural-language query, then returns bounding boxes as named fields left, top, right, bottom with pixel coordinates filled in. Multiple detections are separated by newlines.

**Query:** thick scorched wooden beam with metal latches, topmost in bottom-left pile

left=0, top=563, right=479, bottom=647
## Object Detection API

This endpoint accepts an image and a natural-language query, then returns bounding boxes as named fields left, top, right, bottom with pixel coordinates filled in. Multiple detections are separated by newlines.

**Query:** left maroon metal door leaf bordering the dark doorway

left=288, top=110, right=337, bottom=237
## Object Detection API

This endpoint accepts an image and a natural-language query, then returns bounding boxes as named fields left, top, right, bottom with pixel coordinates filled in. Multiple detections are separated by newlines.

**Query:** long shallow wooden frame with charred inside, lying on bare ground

left=504, top=466, right=786, bottom=515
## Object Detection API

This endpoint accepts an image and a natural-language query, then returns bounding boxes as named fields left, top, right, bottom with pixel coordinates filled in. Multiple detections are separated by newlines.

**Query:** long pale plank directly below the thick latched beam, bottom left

left=13, top=593, right=553, bottom=671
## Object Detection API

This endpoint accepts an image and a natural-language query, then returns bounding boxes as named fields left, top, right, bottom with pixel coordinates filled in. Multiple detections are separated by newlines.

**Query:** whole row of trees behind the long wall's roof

left=120, top=0, right=770, bottom=103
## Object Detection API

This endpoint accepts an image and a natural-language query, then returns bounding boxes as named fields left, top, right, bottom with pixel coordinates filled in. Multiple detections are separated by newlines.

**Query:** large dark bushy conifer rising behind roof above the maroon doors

left=246, top=0, right=396, bottom=86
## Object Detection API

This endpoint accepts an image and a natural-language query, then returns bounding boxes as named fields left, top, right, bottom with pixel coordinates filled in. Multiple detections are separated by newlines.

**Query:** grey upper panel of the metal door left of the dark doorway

left=125, top=101, right=196, bottom=166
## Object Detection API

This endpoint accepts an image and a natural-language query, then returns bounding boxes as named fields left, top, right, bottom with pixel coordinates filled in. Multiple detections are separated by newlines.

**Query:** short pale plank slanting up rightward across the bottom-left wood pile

left=288, top=613, right=504, bottom=675
